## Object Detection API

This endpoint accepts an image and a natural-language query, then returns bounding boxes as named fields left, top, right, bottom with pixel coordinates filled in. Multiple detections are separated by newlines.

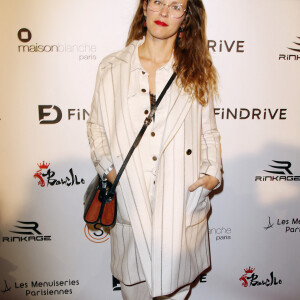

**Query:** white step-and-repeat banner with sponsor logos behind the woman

left=0, top=0, right=300, bottom=300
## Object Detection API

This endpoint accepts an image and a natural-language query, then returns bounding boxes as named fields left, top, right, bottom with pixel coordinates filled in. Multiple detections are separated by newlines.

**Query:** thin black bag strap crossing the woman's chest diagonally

left=110, top=72, right=176, bottom=193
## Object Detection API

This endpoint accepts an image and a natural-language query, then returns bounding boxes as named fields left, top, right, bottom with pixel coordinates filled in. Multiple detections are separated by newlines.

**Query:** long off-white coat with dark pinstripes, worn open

left=88, top=41, right=221, bottom=297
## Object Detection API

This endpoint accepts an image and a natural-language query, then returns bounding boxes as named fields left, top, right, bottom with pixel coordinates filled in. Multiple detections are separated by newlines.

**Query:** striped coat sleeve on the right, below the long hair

left=200, top=100, right=222, bottom=189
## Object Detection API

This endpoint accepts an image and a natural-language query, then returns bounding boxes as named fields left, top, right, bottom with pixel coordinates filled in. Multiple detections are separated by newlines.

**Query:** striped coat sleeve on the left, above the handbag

left=87, top=65, right=112, bottom=178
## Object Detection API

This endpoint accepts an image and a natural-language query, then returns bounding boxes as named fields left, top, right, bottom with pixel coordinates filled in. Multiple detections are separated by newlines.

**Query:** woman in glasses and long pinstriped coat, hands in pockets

left=88, top=0, right=221, bottom=300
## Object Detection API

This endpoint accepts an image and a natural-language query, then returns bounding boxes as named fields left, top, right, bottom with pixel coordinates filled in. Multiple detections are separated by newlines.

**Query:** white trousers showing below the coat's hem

left=120, top=281, right=190, bottom=300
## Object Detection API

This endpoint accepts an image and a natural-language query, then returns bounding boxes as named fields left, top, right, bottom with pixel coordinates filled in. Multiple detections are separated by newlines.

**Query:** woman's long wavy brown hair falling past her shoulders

left=126, top=0, right=218, bottom=105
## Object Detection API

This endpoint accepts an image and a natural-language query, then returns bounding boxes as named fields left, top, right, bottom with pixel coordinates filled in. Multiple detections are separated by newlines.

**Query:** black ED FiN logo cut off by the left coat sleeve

left=38, top=105, right=89, bottom=125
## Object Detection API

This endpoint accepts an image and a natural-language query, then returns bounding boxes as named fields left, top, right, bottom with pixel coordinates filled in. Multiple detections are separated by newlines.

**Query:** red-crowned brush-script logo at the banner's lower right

left=239, top=267, right=282, bottom=287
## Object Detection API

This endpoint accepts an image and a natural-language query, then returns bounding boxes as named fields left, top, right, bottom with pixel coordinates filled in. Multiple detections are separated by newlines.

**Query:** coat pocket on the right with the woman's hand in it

left=186, top=186, right=211, bottom=226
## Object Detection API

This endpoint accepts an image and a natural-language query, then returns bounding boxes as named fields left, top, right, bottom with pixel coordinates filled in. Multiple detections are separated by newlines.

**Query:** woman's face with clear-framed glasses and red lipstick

left=144, top=0, right=188, bottom=39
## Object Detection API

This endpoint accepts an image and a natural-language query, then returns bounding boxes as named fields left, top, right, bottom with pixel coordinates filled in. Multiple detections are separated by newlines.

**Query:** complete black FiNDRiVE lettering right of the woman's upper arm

left=215, top=108, right=287, bottom=120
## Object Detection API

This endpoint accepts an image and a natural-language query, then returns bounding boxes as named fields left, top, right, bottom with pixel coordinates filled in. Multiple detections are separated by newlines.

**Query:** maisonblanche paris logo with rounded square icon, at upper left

left=18, top=28, right=97, bottom=61
